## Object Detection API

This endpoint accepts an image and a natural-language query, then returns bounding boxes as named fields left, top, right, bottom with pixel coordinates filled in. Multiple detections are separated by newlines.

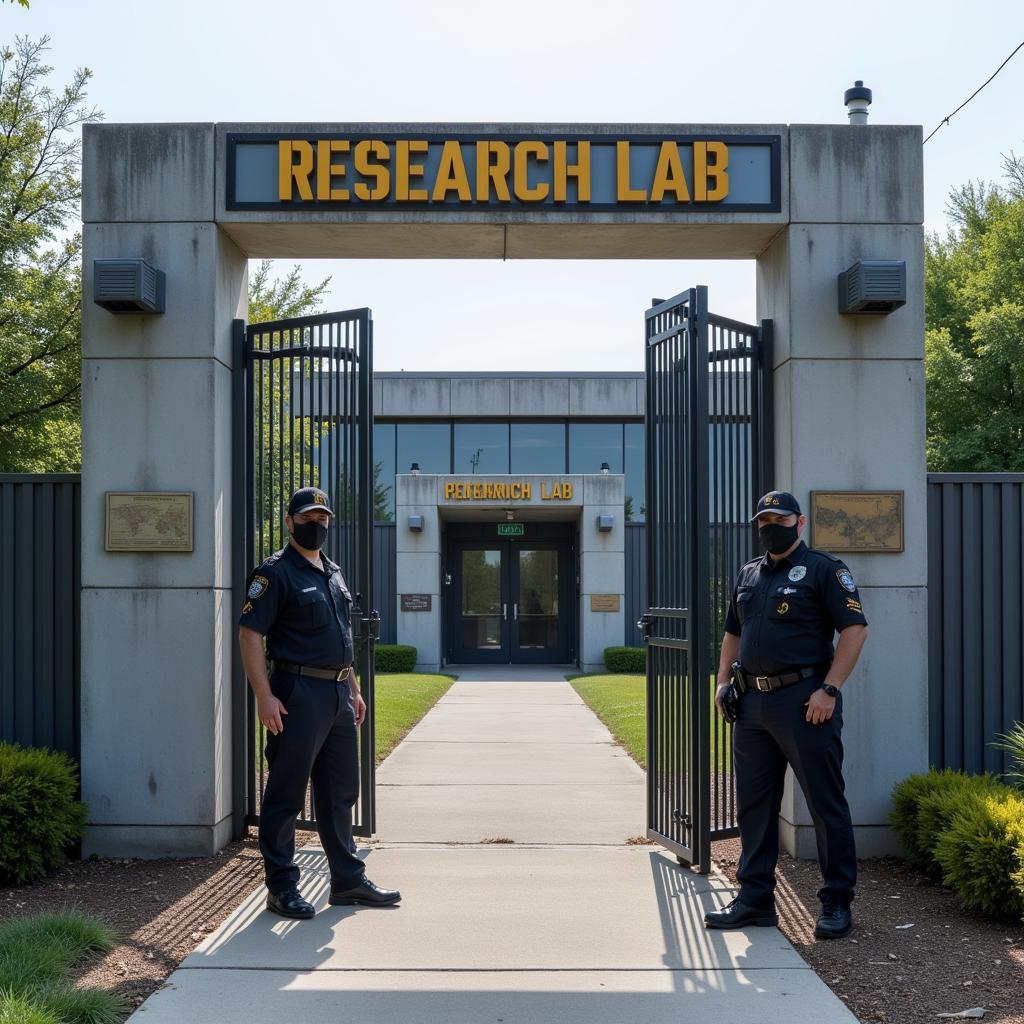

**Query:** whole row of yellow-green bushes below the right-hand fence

left=892, top=769, right=1024, bottom=920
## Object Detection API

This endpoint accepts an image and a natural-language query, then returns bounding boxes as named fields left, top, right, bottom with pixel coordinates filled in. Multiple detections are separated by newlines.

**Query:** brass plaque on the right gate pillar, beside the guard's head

left=811, top=490, right=903, bottom=554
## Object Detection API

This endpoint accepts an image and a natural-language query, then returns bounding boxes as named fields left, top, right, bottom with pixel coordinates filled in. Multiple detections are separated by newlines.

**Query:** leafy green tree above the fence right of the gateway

left=925, top=154, right=1024, bottom=472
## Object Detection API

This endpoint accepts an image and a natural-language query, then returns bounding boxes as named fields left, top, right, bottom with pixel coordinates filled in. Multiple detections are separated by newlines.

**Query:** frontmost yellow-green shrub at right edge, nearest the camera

left=935, top=790, right=1024, bottom=920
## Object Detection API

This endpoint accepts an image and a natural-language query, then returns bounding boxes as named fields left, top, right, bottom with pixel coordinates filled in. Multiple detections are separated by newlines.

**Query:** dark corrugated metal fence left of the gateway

left=0, top=473, right=82, bottom=760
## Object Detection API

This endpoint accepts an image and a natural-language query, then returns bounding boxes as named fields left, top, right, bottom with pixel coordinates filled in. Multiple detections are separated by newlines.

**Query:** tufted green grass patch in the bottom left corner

left=0, top=910, right=124, bottom=1024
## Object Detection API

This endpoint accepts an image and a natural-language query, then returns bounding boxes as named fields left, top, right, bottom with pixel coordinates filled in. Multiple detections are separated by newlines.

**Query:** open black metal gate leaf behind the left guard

left=225, top=309, right=380, bottom=836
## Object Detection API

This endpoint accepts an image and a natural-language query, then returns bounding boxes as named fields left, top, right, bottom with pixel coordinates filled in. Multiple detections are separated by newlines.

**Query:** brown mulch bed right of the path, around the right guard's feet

left=713, top=840, right=1024, bottom=1024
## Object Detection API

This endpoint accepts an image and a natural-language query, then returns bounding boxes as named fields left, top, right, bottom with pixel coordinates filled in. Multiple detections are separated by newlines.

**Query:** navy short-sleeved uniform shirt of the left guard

left=239, top=544, right=353, bottom=669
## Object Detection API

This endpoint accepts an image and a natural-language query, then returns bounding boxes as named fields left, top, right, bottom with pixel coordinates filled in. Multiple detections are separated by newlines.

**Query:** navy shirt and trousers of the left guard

left=239, top=544, right=365, bottom=893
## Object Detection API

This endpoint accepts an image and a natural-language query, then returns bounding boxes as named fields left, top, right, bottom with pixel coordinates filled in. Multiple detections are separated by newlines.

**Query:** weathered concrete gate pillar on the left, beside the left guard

left=82, top=125, right=247, bottom=857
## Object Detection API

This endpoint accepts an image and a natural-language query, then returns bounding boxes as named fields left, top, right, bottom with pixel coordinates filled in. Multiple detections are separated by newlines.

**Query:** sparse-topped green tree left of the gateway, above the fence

left=0, top=36, right=100, bottom=472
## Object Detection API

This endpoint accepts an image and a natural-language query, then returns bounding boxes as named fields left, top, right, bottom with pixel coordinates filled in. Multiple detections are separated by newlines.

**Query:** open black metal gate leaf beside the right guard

left=642, top=287, right=773, bottom=872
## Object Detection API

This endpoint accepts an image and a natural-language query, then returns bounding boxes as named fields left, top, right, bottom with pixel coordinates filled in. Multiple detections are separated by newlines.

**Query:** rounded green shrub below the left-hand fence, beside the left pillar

left=0, top=743, right=85, bottom=886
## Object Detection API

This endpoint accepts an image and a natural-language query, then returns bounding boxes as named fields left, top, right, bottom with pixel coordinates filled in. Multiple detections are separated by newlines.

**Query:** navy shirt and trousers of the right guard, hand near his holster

left=725, top=542, right=867, bottom=910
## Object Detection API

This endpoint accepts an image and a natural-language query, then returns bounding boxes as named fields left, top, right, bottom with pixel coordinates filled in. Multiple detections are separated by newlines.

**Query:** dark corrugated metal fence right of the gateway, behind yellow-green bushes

left=928, top=473, right=1024, bottom=772
